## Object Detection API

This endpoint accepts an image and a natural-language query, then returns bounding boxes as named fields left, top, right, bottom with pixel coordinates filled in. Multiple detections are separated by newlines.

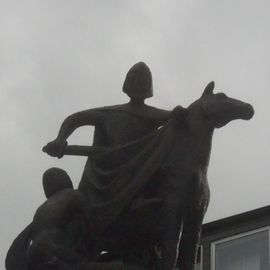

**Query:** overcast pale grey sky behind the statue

left=0, top=0, right=270, bottom=269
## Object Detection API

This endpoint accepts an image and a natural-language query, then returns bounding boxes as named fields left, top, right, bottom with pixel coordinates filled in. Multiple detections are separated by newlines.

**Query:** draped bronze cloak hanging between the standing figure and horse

left=79, top=119, right=177, bottom=234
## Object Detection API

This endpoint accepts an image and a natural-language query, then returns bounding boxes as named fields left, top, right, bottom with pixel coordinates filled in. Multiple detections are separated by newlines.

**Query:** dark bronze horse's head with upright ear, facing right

left=190, top=82, right=254, bottom=128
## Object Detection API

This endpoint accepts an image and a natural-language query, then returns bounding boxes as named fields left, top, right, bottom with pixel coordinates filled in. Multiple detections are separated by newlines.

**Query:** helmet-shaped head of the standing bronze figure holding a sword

left=123, top=62, right=153, bottom=100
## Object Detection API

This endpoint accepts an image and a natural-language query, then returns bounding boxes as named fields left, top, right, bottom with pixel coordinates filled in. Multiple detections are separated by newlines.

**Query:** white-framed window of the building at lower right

left=211, top=228, right=270, bottom=270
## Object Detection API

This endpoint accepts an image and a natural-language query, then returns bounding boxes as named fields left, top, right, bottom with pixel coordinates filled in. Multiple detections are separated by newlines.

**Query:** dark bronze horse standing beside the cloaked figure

left=5, top=82, right=254, bottom=270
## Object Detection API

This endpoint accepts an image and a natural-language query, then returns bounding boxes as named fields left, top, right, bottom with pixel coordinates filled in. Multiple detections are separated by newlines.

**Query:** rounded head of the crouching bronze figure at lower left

left=42, top=168, right=73, bottom=198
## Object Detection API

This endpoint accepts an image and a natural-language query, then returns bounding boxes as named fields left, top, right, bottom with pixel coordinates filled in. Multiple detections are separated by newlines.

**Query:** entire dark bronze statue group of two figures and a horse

left=6, top=62, right=254, bottom=270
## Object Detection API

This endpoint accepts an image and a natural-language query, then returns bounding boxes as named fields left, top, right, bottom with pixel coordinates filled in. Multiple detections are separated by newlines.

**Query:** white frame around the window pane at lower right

left=210, top=226, right=270, bottom=270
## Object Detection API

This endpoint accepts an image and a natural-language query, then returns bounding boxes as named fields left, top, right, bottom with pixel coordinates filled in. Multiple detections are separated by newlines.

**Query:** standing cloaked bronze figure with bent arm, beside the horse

left=44, top=62, right=172, bottom=233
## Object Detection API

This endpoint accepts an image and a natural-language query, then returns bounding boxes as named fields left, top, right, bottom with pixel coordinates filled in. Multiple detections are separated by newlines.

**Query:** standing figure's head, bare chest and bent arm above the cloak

left=44, top=62, right=171, bottom=190
